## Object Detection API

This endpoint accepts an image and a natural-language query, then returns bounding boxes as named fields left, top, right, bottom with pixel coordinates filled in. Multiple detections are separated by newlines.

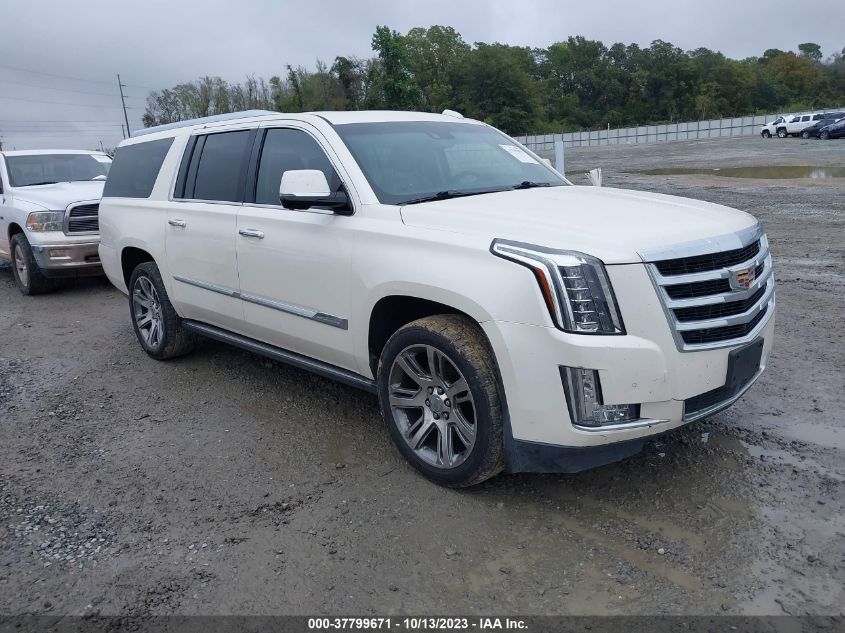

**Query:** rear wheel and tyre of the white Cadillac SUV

left=129, top=262, right=196, bottom=360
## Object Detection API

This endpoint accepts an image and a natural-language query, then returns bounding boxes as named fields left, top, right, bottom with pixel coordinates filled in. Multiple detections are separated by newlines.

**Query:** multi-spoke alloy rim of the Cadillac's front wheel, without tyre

left=388, top=345, right=478, bottom=469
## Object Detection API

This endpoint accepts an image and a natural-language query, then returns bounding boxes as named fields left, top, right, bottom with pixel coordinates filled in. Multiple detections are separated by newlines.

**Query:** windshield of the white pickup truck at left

left=6, top=154, right=111, bottom=187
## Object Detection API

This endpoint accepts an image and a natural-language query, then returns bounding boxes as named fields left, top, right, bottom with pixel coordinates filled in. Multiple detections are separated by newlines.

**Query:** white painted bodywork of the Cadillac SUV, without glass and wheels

left=95, top=112, right=774, bottom=447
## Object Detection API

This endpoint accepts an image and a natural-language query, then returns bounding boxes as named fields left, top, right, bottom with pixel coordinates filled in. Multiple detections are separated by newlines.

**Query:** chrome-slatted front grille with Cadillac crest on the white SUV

left=643, top=226, right=775, bottom=351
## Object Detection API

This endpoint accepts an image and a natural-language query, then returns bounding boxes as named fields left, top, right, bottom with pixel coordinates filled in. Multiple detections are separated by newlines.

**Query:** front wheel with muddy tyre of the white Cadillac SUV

left=378, top=314, right=504, bottom=488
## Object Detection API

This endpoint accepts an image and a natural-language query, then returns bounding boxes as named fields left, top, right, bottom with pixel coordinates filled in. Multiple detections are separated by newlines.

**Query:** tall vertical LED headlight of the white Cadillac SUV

left=490, top=239, right=625, bottom=334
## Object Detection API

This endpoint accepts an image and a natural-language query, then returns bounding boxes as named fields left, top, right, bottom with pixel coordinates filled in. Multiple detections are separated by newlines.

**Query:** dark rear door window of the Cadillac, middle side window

left=179, top=130, right=251, bottom=202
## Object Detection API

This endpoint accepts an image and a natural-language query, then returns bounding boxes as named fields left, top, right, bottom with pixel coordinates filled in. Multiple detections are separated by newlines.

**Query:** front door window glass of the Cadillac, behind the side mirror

left=255, top=128, right=341, bottom=205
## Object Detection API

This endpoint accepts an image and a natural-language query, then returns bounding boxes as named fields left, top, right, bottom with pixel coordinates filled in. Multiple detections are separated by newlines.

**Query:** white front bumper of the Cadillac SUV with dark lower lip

left=481, top=265, right=774, bottom=472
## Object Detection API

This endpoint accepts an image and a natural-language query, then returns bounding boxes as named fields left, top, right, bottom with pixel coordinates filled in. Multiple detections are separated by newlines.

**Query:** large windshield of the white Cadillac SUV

left=335, top=121, right=566, bottom=204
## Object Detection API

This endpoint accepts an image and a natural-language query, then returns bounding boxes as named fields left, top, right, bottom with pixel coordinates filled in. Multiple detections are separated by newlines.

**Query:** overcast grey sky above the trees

left=0, top=0, right=845, bottom=149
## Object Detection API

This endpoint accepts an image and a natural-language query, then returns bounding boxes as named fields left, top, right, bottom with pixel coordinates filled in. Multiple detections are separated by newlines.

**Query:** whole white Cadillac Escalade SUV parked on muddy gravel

left=95, top=112, right=775, bottom=486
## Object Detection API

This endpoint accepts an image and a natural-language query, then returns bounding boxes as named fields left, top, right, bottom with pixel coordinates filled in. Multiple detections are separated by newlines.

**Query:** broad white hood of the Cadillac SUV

left=402, top=186, right=757, bottom=264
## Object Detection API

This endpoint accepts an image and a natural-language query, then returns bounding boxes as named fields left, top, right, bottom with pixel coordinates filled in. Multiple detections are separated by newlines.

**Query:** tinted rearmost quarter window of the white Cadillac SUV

left=103, top=138, right=173, bottom=198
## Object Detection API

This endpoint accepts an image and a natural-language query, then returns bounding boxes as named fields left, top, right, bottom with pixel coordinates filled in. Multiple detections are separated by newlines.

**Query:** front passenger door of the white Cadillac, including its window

left=236, top=127, right=356, bottom=370
